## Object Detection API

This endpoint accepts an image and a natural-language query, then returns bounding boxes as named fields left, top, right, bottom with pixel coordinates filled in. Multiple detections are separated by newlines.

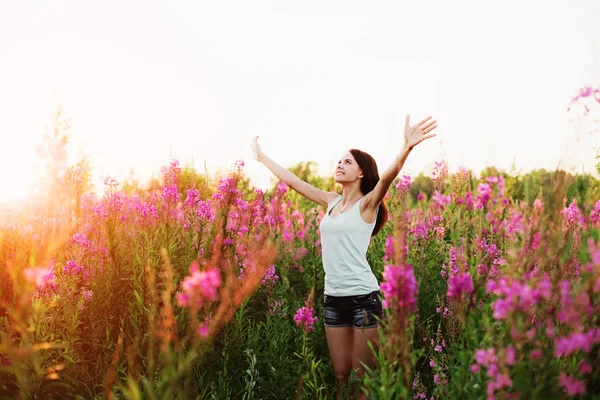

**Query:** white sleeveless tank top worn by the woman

left=320, top=196, right=379, bottom=296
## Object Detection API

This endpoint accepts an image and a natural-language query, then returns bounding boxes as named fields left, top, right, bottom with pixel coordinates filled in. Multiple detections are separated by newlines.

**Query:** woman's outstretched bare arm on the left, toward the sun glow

left=252, top=136, right=337, bottom=207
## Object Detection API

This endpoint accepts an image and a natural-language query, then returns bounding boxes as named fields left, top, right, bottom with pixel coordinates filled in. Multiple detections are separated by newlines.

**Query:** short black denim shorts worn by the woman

left=323, top=291, right=383, bottom=328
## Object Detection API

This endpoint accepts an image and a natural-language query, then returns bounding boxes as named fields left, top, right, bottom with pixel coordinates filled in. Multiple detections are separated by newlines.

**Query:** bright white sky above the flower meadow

left=0, top=0, right=600, bottom=199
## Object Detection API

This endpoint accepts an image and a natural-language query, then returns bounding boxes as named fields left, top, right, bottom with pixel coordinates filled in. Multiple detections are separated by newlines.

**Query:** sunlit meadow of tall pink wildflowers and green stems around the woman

left=0, top=120, right=600, bottom=400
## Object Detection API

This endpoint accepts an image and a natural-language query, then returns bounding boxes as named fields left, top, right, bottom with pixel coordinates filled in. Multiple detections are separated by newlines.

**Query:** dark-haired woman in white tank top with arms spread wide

left=252, top=115, right=437, bottom=399
